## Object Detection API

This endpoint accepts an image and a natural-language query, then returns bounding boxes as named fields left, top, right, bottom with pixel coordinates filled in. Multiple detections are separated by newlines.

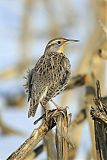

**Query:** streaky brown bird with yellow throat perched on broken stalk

left=26, top=38, right=78, bottom=117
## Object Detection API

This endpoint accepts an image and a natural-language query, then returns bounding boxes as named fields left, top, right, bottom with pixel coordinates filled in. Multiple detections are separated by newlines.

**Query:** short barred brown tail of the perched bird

left=28, top=100, right=39, bottom=118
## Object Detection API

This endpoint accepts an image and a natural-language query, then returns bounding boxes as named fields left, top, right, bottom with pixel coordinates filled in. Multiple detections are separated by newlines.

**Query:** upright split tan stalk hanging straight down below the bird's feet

left=56, top=109, right=68, bottom=160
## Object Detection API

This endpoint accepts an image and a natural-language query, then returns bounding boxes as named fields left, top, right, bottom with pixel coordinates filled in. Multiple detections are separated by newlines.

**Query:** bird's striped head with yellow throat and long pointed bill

left=45, top=38, right=79, bottom=53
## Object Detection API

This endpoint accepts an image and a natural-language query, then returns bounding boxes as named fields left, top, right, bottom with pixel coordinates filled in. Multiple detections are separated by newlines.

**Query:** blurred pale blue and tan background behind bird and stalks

left=0, top=0, right=107, bottom=160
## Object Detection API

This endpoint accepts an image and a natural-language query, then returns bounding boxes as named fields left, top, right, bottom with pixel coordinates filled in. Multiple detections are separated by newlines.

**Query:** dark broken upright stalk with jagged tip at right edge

left=90, top=81, right=107, bottom=160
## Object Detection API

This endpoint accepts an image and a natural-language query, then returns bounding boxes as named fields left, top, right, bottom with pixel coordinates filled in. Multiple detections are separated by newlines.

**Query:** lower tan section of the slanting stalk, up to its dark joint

left=7, top=122, right=52, bottom=160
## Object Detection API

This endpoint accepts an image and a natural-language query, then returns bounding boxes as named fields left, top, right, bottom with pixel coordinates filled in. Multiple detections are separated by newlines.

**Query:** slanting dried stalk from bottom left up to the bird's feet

left=7, top=110, right=70, bottom=160
